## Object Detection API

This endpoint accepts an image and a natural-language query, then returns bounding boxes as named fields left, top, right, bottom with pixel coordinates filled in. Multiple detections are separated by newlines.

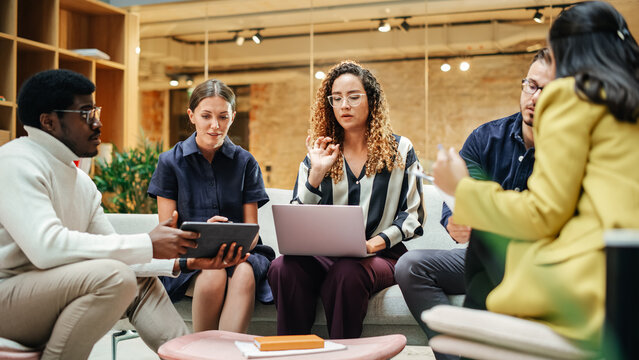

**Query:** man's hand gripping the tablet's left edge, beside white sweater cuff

left=149, top=211, right=200, bottom=259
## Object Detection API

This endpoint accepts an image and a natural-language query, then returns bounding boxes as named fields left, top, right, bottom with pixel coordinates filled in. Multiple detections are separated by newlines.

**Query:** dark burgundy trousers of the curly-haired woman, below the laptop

left=268, top=255, right=397, bottom=339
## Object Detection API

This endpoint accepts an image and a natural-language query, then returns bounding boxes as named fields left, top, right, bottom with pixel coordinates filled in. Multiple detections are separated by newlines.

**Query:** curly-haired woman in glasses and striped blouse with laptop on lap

left=268, top=61, right=426, bottom=339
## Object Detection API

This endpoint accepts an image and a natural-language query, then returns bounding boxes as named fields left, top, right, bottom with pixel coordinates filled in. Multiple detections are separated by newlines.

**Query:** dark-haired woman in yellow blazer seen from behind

left=433, top=2, right=639, bottom=348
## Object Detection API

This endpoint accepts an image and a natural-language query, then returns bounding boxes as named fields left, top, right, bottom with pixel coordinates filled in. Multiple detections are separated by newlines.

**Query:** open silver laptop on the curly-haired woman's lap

left=273, top=205, right=369, bottom=257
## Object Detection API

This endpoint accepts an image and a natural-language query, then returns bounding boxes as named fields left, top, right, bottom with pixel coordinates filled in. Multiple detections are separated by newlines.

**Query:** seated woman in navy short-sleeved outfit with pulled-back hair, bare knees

left=148, top=80, right=275, bottom=332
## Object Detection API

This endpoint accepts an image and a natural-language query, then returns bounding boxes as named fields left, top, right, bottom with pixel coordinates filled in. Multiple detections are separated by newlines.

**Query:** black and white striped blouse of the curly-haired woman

left=291, top=135, right=426, bottom=255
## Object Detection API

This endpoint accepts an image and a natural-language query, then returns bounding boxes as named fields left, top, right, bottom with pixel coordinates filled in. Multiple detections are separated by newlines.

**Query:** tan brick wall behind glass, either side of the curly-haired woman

left=249, top=55, right=532, bottom=188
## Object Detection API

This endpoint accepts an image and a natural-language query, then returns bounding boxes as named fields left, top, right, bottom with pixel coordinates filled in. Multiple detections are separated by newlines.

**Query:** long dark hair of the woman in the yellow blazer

left=549, top=1, right=639, bottom=123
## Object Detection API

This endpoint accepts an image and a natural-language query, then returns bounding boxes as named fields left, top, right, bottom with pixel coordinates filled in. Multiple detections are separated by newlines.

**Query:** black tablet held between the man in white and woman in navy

left=180, top=221, right=260, bottom=258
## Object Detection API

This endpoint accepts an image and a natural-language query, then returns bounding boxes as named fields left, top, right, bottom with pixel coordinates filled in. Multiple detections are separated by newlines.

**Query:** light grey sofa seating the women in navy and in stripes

left=107, top=185, right=463, bottom=345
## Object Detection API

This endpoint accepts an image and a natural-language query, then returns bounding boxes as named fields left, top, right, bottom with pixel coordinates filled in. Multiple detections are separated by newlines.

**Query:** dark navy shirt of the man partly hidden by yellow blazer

left=441, top=113, right=535, bottom=228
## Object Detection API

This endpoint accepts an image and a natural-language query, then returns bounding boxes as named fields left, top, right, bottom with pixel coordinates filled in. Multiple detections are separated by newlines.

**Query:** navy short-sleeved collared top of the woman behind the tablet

left=148, top=133, right=268, bottom=226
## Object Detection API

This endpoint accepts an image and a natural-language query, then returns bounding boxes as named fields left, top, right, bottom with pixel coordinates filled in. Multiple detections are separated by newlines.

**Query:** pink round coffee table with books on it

left=158, top=330, right=406, bottom=360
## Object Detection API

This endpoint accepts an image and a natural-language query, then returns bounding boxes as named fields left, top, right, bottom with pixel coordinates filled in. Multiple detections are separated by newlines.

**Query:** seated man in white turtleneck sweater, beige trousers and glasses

left=0, top=70, right=240, bottom=359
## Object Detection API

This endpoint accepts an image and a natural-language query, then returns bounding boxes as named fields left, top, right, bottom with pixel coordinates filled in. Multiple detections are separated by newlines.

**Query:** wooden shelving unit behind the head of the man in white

left=0, top=0, right=138, bottom=148
